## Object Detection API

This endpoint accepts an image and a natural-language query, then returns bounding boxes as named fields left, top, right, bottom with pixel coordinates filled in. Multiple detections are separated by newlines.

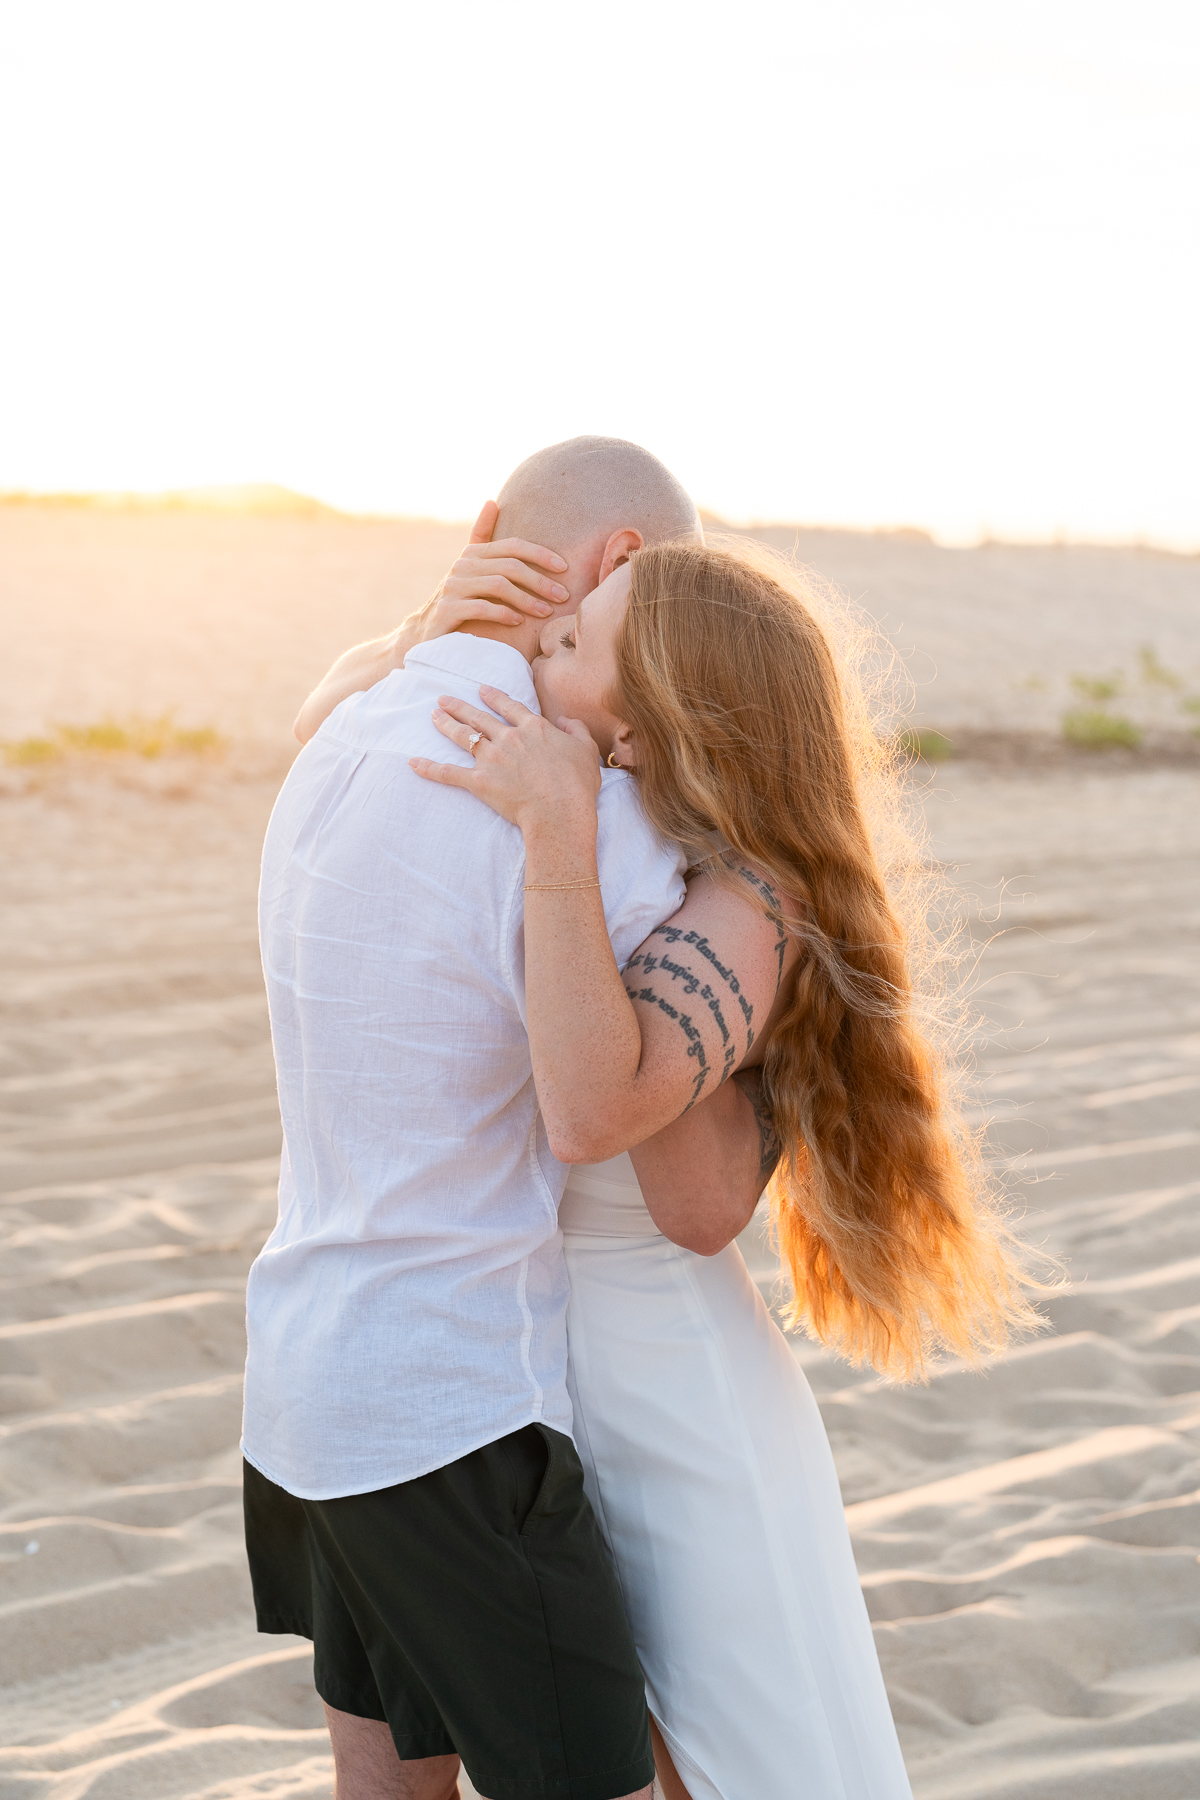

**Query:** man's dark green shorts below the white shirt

left=245, top=1426, right=655, bottom=1800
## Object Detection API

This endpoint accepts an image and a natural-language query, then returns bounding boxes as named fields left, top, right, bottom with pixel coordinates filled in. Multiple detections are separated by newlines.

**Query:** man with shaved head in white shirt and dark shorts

left=243, top=437, right=752, bottom=1800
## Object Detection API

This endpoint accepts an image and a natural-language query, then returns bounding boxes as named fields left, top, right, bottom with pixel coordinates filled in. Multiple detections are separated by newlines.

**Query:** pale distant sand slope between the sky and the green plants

left=0, top=506, right=1200, bottom=747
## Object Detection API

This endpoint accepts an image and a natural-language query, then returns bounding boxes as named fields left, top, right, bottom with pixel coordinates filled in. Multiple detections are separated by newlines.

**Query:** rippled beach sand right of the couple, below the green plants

left=788, top=769, right=1200, bottom=1800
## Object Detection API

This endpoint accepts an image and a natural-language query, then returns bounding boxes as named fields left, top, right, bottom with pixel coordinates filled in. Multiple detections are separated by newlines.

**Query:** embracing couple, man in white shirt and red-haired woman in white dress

left=243, top=437, right=1025, bottom=1800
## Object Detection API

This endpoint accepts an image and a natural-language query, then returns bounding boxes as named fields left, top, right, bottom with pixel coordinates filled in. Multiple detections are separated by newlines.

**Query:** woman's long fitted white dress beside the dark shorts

left=560, top=1156, right=912, bottom=1800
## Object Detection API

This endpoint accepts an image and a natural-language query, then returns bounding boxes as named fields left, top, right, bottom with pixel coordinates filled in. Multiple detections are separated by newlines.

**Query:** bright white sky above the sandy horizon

left=0, top=0, right=1200, bottom=547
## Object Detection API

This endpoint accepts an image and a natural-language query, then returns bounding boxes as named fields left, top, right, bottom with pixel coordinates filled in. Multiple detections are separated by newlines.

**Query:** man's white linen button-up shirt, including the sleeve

left=243, top=632, right=684, bottom=1499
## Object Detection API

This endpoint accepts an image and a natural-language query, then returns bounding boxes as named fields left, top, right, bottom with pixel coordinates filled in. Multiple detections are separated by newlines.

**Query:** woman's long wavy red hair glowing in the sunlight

left=612, top=544, right=1036, bottom=1379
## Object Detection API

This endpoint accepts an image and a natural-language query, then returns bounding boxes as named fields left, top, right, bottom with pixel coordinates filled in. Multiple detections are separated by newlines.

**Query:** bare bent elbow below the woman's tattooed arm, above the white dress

left=630, top=1069, right=779, bottom=1256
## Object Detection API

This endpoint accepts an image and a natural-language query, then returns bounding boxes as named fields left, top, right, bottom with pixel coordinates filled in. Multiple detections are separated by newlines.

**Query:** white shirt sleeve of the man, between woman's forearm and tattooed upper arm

left=596, top=770, right=687, bottom=968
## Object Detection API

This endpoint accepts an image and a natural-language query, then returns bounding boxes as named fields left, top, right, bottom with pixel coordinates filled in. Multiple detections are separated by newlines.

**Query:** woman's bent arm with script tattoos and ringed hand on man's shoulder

left=412, top=688, right=797, bottom=1163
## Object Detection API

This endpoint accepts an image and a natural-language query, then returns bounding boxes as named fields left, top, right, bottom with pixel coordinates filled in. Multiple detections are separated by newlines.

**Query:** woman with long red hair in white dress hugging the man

left=412, top=545, right=1031, bottom=1800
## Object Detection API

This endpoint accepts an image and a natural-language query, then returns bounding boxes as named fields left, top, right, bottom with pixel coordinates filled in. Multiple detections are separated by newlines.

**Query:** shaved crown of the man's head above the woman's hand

left=493, top=437, right=703, bottom=556
